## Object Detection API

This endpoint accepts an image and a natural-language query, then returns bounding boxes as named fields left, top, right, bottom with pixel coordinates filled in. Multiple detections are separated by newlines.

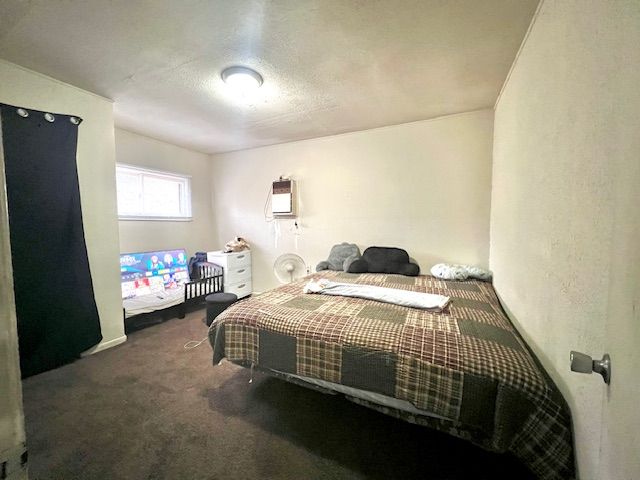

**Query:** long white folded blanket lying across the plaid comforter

left=302, top=278, right=450, bottom=310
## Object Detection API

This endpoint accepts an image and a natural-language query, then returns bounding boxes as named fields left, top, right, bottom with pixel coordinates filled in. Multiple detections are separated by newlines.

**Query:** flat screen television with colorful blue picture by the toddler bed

left=120, top=249, right=189, bottom=298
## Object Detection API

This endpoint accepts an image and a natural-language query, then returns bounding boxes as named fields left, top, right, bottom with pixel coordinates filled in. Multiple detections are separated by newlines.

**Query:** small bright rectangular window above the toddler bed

left=116, top=165, right=191, bottom=220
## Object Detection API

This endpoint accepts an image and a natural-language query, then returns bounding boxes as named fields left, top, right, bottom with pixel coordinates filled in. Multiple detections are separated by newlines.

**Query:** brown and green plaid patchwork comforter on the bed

left=209, top=272, right=575, bottom=480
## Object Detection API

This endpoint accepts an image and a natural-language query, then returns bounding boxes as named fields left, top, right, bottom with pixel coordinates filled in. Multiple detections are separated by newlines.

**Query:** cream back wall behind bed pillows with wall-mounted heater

left=211, top=110, right=493, bottom=291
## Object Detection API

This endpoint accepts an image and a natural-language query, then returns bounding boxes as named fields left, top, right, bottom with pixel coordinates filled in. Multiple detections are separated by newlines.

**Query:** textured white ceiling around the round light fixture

left=0, top=0, right=538, bottom=153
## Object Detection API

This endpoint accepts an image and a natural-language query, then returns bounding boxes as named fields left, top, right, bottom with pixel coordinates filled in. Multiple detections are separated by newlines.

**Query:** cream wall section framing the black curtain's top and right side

left=0, top=61, right=126, bottom=348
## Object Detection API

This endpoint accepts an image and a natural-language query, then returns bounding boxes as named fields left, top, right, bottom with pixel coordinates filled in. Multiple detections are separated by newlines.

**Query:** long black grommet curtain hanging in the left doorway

left=0, top=104, right=102, bottom=377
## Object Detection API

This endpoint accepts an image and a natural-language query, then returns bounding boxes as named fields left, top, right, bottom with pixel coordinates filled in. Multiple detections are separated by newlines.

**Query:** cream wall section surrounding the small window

left=115, top=128, right=215, bottom=255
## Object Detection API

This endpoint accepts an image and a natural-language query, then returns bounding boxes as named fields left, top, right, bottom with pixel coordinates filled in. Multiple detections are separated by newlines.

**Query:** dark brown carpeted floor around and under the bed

left=23, top=311, right=531, bottom=480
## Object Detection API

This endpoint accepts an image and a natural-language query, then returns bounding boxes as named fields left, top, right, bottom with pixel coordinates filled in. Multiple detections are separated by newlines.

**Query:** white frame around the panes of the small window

left=115, top=163, right=193, bottom=222
